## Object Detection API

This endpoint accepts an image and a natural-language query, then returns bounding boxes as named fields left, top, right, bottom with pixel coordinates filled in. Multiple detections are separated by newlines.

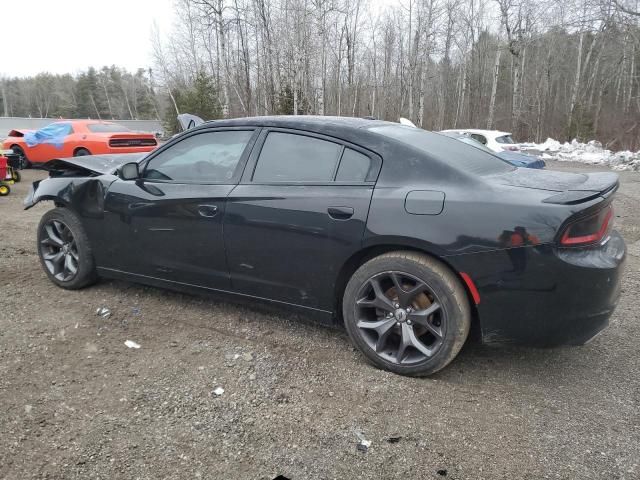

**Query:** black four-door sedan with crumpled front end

left=25, top=116, right=625, bottom=375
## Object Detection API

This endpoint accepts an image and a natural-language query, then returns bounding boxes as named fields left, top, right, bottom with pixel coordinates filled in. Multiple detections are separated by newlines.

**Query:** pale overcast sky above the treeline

left=0, top=0, right=174, bottom=77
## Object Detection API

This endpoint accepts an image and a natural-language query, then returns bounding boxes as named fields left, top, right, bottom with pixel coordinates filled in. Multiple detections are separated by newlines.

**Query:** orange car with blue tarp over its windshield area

left=2, top=120, right=158, bottom=164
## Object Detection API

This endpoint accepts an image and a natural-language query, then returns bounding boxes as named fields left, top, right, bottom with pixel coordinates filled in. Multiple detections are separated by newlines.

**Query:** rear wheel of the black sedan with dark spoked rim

left=342, top=251, right=471, bottom=376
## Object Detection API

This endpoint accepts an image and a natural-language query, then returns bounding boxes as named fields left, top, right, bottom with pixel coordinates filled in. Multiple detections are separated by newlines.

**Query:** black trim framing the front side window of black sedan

left=140, top=125, right=261, bottom=185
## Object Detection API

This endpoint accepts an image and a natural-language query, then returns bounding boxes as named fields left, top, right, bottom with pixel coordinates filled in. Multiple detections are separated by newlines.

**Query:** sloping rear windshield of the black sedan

left=370, top=125, right=515, bottom=175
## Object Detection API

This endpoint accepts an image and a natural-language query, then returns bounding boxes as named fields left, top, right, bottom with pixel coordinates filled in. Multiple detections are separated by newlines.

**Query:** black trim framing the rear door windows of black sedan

left=240, top=127, right=382, bottom=186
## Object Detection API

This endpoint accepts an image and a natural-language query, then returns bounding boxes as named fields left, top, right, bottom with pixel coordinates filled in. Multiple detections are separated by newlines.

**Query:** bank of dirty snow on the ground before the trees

left=520, top=138, right=640, bottom=171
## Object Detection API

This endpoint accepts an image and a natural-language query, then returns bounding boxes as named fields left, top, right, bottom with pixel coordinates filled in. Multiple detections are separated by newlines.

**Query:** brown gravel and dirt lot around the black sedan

left=0, top=164, right=640, bottom=479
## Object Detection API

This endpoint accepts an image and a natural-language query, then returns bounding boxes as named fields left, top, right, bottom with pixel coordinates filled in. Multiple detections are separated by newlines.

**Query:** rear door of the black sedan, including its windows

left=224, top=129, right=381, bottom=311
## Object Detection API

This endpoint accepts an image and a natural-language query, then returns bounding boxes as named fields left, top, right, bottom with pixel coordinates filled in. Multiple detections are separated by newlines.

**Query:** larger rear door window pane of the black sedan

left=253, top=132, right=342, bottom=182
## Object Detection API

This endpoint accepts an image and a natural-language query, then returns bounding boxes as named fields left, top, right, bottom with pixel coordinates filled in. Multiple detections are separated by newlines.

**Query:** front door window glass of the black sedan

left=143, top=130, right=253, bottom=183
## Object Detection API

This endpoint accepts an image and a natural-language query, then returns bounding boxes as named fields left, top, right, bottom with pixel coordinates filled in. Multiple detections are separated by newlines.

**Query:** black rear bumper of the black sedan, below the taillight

left=454, top=231, right=626, bottom=347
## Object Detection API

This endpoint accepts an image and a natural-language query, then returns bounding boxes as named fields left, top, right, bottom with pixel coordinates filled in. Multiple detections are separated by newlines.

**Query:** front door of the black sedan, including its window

left=98, top=129, right=254, bottom=290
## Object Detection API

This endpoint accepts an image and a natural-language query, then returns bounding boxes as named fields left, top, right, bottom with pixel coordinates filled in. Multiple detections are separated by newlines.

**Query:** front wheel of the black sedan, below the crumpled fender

left=37, top=208, right=98, bottom=290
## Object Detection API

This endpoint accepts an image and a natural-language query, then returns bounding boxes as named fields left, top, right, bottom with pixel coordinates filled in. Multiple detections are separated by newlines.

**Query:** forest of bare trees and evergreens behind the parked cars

left=0, top=0, right=640, bottom=150
